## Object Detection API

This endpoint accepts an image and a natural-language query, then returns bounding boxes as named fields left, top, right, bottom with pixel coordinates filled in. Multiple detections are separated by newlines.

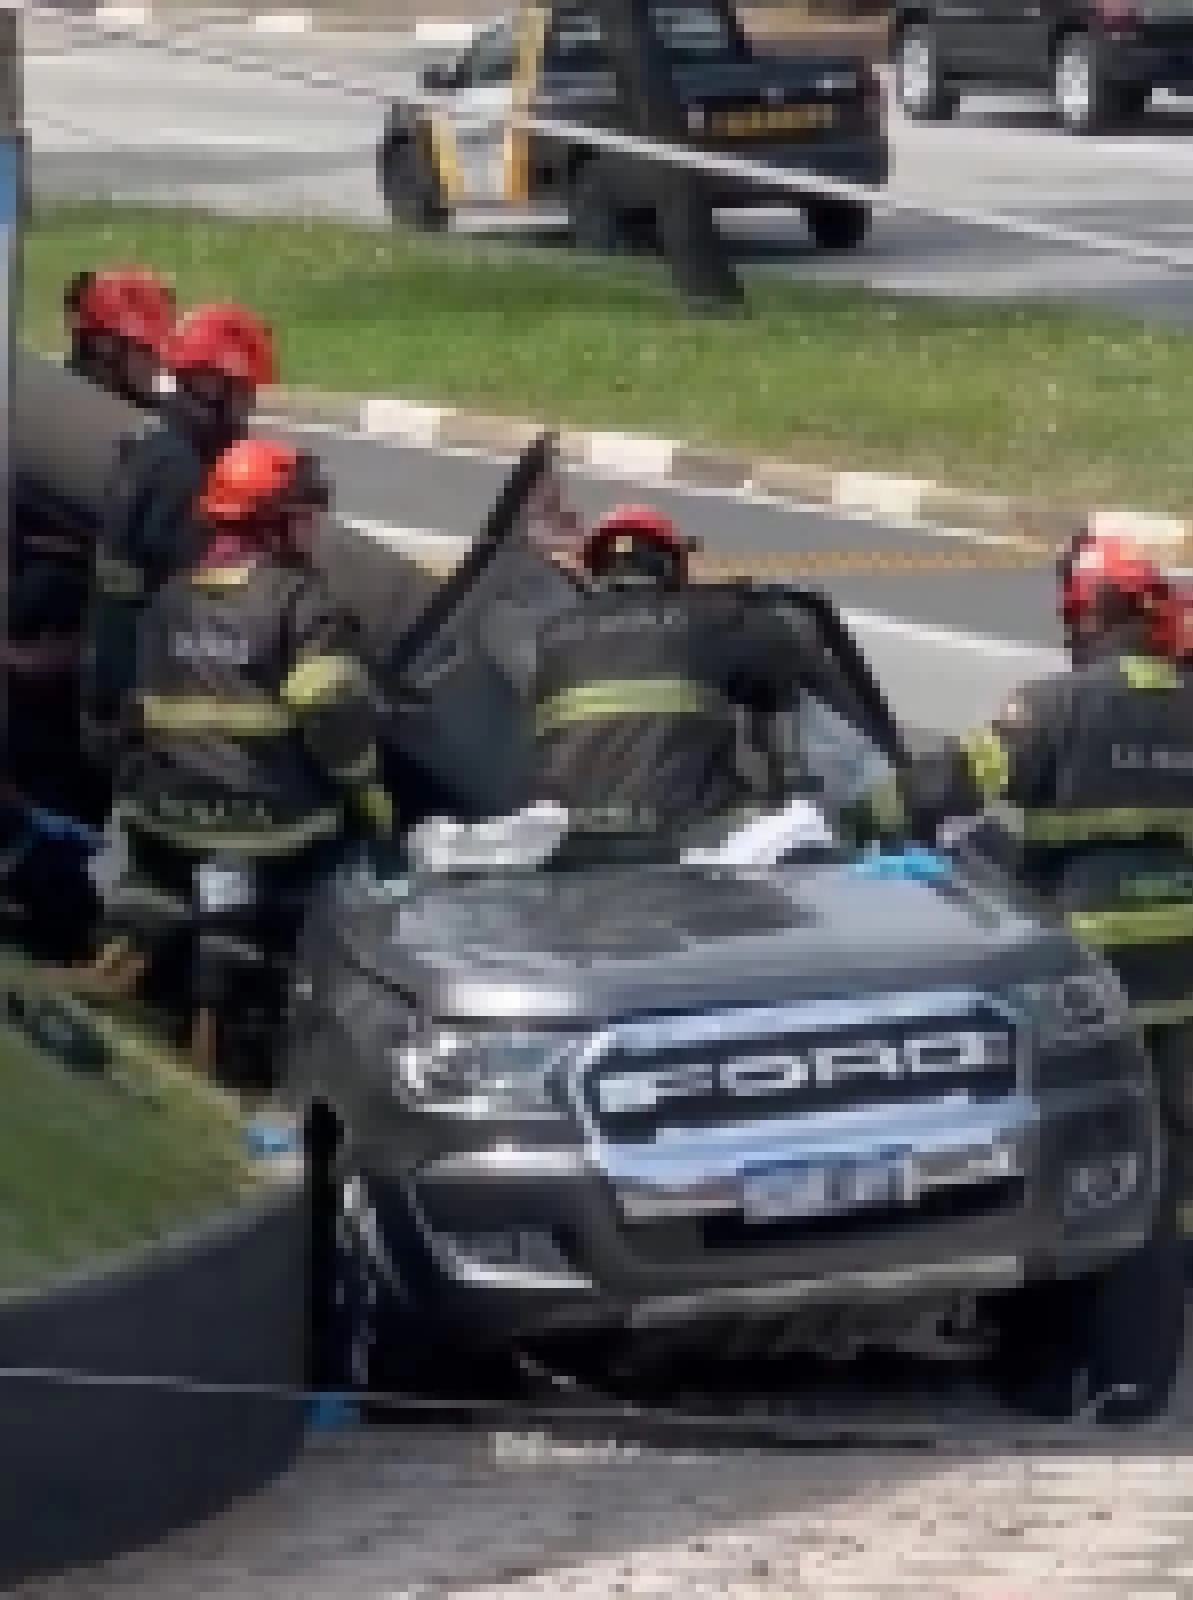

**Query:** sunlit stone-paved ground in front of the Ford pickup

left=14, top=1344, right=1193, bottom=1600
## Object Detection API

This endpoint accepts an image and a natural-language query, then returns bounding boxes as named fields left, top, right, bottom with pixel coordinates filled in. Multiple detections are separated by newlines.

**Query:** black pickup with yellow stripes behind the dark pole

left=377, top=0, right=891, bottom=254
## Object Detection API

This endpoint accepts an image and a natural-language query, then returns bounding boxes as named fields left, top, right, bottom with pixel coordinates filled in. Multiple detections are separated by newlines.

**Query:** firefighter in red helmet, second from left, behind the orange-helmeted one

left=82, top=304, right=277, bottom=763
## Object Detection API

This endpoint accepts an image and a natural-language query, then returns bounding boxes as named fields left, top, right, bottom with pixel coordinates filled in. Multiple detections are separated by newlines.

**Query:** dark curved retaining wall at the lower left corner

left=0, top=1182, right=309, bottom=1587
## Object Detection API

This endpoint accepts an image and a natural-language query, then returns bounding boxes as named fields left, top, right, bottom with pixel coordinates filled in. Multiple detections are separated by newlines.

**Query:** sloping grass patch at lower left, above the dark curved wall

left=0, top=963, right=259, bottom=1294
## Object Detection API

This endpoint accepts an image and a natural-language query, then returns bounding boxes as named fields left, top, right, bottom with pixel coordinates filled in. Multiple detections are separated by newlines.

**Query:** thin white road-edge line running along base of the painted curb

left=259, top=413, right=1039, bottom=555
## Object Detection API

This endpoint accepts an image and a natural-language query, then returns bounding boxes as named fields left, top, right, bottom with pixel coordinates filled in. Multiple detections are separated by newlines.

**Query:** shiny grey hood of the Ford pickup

left=329, top=864, right=1073, bottom=1021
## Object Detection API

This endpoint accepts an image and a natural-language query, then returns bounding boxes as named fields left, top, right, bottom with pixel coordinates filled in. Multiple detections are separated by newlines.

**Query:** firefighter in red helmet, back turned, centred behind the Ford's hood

left=529, top=506, right=816, bottom=827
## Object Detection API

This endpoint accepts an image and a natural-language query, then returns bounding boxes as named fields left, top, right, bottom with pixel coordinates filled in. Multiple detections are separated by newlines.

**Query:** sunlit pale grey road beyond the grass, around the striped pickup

left=26, top=22, right=1193, bottom=320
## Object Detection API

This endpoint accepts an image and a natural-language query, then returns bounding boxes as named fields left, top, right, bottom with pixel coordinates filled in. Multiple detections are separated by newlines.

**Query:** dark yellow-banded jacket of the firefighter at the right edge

left=910, top=650, right=1193, bottom=1026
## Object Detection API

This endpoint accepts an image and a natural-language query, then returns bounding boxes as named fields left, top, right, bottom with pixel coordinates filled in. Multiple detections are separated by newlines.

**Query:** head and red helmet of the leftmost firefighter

left=62, top=267, right=178, bottom=408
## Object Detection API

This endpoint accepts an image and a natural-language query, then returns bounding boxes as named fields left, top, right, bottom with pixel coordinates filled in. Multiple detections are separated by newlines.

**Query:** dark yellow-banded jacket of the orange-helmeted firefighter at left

left=118, top=563, right=390, bottom=858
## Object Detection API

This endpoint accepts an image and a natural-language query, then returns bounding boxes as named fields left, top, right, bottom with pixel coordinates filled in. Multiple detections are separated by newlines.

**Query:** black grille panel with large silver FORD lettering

left=590, top=1027, right=1014, bottom=1123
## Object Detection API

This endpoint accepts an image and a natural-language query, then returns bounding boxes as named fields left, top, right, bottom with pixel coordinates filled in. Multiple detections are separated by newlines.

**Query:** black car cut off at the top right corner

left=894, top=0, right=1193, bottom=133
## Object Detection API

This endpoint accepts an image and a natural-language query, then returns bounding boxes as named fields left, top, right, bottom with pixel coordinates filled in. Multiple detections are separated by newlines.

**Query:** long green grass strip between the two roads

left=24, top=203, right=1193, bottom=514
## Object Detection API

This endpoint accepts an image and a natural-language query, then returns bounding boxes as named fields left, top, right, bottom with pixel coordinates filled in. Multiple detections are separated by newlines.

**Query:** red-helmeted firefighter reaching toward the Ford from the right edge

left=905, top=533, right=1193, bottom=1237
